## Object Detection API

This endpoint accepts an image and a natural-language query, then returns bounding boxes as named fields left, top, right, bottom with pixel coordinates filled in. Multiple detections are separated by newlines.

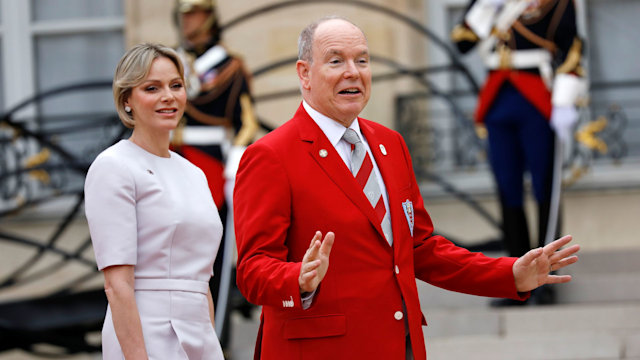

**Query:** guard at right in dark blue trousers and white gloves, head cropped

left=451, top=0, right=584, bottom=304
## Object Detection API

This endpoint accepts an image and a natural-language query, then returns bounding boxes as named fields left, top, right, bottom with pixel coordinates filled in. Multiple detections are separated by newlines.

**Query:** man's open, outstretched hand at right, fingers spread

left=513, top=235, right=580, bottom=292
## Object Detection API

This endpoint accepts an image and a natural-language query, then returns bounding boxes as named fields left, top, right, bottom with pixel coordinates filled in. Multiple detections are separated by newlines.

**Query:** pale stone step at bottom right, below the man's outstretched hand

left=425, top=302, right=640, bottom=360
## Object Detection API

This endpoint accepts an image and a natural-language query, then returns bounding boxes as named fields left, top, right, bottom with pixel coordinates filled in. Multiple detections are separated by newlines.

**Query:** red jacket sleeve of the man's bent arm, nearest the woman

left=234, top=142, right=311, bottom=309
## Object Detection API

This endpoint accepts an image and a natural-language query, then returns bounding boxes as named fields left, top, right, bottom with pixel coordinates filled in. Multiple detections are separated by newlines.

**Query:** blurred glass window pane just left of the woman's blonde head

left=32, top=0, right=124, bottom=115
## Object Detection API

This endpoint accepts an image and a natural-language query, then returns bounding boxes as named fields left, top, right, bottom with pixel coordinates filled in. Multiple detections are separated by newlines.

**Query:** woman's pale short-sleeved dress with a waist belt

left=85, top=140, right=224, bottom=360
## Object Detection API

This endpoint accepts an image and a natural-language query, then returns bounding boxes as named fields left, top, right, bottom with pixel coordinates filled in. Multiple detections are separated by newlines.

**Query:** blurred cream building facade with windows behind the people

left=0, top=0, right=640, bottom=202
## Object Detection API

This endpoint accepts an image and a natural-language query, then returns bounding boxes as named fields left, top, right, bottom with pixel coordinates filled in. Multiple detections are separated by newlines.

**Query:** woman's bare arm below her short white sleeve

left=102, top=265, right=148, bottom=360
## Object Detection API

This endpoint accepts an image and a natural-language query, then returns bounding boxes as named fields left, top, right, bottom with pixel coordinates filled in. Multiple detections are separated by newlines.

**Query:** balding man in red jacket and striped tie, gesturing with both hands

left=234, top=18, right=578, bottom=360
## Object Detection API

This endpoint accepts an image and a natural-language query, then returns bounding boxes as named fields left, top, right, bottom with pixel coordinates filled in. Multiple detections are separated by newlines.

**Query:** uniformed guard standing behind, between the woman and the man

left=172, top=0, right=259, bottom=347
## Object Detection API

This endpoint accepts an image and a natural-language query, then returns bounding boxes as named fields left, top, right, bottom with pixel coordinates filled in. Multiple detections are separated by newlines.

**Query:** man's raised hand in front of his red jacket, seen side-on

left=298, top=231, right=335, bottom=294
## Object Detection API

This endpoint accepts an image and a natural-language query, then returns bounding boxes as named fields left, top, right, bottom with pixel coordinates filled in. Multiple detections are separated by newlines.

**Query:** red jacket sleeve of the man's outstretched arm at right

left=402, top=134, right=529, bottom=299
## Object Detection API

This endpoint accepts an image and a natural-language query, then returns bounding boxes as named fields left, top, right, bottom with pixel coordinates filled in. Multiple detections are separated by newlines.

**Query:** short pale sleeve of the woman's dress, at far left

left=84, top=153, right=138, bottom=270
